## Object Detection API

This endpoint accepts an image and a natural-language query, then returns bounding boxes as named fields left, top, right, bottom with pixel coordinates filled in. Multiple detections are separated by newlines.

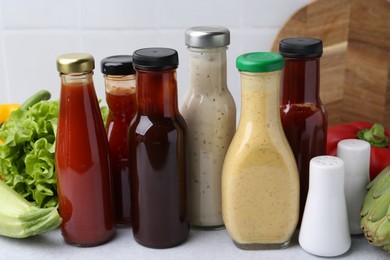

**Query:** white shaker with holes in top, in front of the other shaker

left=299, top=156, right=351, bottom=257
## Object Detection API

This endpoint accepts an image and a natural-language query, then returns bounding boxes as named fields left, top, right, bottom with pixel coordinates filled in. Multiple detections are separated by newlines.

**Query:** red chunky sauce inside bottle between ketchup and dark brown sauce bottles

left=106, top=88, right=136, bottom=225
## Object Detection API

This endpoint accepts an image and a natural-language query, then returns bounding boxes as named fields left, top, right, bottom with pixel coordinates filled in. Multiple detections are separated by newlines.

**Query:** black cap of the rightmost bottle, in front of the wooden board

left=279, top=38, right=323, bottom=58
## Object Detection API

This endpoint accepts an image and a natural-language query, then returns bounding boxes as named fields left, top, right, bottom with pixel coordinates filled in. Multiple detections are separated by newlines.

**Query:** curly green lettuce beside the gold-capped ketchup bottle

left=0, top=98, right=58, bottom=208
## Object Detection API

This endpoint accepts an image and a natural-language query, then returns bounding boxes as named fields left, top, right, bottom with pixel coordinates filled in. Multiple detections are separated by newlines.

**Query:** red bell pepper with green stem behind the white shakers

left=326, top=122, right=390, bottom=180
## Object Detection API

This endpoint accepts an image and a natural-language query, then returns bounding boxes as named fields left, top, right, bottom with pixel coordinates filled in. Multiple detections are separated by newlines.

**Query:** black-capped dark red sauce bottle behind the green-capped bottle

left=279, top=38, right=328, bottom=225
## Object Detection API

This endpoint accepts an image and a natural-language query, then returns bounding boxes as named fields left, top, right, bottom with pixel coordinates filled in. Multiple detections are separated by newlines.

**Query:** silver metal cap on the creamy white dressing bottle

left=185, top=26, right=230, bottom=48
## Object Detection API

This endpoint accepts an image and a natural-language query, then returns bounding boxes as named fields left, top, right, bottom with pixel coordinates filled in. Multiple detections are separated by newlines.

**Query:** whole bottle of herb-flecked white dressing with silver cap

left=181, top=26, right=236, bottom=229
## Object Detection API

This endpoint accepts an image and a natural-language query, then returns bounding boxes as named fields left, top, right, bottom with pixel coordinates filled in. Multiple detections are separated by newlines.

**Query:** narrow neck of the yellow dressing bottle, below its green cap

left=240, top=71, right=281, bottom=128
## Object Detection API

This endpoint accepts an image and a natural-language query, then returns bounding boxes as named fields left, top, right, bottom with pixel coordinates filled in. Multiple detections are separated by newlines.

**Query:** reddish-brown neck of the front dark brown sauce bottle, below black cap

left=136, top=69, right=178, bottom=117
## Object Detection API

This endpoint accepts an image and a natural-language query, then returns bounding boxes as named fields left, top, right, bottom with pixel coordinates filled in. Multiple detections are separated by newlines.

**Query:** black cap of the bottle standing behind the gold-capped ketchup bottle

left=100, top=55, right=135, bottom=75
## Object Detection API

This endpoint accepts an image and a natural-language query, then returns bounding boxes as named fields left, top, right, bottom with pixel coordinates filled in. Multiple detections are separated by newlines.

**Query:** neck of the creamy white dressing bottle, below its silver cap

left=188, top=47, right=227, bottom=94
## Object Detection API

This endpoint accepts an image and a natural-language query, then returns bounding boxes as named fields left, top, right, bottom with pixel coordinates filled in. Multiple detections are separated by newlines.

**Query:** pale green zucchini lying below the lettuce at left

left=0, top=181, right=62, bottom=238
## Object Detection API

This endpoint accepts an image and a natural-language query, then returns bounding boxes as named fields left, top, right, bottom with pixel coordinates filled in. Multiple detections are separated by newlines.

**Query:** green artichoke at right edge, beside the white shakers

left=360, top=166, right=390, bottom=253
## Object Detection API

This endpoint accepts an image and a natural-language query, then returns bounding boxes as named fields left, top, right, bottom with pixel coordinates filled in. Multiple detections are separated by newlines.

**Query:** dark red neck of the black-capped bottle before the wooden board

left=280, top=57, right=320, bottom=105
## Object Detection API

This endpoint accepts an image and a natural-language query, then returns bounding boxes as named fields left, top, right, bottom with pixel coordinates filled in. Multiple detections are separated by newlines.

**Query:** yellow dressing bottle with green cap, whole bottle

left=222, top=52, right=299, bottom=250
